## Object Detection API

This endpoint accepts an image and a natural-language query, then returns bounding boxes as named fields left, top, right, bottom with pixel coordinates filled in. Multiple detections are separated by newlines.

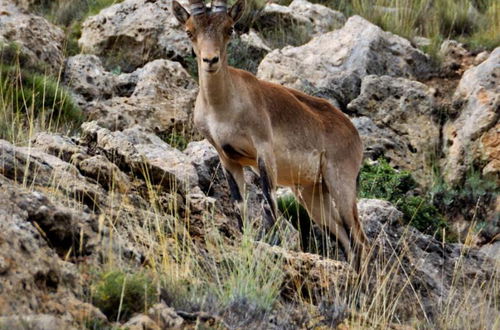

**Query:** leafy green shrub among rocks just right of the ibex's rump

left=359, top=158, right=447, bottom=238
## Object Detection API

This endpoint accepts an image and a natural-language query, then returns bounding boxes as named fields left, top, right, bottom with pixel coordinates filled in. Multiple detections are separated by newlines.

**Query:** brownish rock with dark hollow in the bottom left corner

left=0, top=175, right=93, bottom=320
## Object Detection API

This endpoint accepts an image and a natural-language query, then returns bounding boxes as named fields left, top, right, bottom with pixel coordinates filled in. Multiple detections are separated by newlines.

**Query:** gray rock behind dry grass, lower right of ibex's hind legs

left=358, top=200, right=498, bottom=322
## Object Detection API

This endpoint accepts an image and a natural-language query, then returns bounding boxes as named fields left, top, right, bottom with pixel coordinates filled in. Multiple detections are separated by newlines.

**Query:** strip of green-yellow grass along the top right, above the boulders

left=306, top=0, right=500, bottom=54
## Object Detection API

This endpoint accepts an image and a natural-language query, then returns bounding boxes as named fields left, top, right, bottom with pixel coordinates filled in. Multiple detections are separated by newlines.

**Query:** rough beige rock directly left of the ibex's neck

left=86, top=60, right=198, bottom=135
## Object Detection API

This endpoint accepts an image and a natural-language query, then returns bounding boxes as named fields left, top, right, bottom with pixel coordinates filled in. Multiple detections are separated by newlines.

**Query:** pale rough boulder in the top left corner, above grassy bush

left=0, top=1, right=65, bottom=74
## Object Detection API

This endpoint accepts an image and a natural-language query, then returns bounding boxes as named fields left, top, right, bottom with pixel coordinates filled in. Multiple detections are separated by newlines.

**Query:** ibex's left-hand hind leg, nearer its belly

left=296, top=183, right=352, bottom=258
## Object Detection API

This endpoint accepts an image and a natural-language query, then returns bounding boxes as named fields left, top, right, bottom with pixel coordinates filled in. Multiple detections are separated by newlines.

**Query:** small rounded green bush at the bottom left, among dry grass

left=92, top=270, right=158, bottom=321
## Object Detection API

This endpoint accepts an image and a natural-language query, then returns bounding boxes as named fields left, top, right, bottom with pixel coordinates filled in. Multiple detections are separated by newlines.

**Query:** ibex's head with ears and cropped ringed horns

left=172, top=0, right=245, bottom=73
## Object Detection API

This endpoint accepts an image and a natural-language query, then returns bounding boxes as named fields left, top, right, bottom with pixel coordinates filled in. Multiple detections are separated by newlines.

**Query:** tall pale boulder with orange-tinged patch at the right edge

left=443, top=48, right=500, bottom=186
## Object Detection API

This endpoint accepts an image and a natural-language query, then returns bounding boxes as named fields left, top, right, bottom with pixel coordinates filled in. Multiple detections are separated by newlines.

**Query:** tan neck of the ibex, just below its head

left=198, top=64, right=233, bottom=107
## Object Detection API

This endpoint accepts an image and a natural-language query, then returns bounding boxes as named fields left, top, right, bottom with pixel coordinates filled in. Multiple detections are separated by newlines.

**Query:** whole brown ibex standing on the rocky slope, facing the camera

left=173, top=0, right=366, bottom=266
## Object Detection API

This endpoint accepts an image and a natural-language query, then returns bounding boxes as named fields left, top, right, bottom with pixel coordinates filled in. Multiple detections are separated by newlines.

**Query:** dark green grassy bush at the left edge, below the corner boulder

left=0, top=44, right=83, bottom=142
